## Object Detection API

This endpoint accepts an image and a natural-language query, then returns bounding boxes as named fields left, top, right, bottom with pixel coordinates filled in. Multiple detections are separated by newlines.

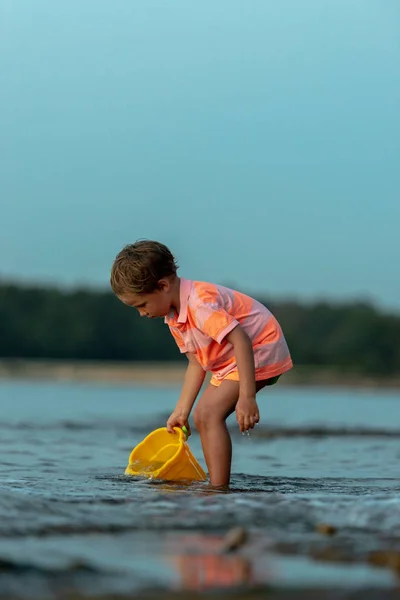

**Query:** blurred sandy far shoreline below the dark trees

left=0, top=359, right=400, bottom=390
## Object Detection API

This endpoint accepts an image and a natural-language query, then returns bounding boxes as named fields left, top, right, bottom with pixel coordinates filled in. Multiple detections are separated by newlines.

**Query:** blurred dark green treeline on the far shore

left=0, top=282, right=400, bottom=375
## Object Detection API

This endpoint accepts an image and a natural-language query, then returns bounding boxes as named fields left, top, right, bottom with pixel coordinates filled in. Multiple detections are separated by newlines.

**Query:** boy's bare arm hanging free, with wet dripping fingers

left=226, top=325, right=260, bottom=431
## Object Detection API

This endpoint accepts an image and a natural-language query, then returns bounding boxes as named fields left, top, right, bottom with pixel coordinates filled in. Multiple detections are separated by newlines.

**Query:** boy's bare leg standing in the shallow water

left=193, top=379, right=266, bottom=487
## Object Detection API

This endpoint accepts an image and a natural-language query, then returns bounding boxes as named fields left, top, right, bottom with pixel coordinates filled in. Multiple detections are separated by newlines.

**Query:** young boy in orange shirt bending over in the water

left=111, top=240, right=293, bottom=487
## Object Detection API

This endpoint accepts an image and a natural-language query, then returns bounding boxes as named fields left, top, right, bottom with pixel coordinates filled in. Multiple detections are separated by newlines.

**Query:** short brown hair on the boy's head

left=110, top=240, right=178, bottom=296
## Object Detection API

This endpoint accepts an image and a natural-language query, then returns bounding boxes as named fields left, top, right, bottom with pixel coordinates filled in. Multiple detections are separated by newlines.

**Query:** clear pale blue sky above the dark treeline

left=0, top=0, right=400, bottom=310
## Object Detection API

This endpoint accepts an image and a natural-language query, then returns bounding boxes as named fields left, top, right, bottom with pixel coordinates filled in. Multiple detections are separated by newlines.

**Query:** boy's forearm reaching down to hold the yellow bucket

left=167, top=352, right=206, bottom=433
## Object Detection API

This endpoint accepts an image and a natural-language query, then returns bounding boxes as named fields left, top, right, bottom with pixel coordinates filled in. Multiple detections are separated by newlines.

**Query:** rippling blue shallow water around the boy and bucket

left=0, top=381, right=400, bottom=598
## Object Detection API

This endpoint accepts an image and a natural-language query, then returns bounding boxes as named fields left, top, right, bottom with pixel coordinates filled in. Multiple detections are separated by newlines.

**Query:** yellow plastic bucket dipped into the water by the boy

left=125, top=427, right=206, bottom=481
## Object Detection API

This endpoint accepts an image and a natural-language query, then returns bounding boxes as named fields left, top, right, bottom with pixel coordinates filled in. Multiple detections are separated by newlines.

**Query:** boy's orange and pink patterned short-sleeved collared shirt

left=165, top=277, right=293, bottom=385
